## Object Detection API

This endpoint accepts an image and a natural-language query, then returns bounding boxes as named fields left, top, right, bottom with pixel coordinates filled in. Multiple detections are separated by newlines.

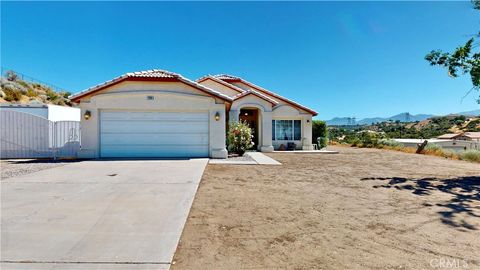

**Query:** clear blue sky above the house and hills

left=1, top=1, right=480, bottom=119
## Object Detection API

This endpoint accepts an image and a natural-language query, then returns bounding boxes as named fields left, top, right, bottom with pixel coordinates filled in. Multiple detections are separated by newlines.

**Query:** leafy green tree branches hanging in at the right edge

left=425, top=0, right=480, bottom=104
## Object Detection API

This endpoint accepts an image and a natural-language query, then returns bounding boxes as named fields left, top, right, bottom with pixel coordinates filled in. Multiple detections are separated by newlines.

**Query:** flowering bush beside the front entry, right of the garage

left=227, top=121, right=254, bottom=155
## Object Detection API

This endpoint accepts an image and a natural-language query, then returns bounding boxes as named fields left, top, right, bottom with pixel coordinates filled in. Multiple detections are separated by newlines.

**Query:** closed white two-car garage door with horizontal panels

left=100, top=111, right=209, bottom=157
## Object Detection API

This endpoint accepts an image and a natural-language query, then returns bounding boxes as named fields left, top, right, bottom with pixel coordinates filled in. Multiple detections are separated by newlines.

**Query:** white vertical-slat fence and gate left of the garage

left=0, top=110, right=80, bottom=159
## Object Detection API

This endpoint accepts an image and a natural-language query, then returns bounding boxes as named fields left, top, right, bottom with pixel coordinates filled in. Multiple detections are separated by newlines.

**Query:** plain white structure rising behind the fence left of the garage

left=0, top=103, right=80, bottom=122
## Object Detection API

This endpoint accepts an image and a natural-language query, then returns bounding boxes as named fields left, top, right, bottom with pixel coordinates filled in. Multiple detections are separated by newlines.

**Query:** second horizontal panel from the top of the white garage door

left=101, top=120, right=208, bottom=133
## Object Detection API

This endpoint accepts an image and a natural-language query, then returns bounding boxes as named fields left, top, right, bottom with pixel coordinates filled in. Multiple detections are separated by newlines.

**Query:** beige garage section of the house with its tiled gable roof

left=71, top=69, right=233, bottom=158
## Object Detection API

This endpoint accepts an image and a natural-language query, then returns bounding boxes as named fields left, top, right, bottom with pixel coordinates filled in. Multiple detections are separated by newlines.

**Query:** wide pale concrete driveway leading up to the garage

left=1, top=159, right=208, bottom=269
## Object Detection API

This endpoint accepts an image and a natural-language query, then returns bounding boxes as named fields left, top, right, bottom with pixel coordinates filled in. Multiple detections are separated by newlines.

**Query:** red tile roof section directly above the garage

left=70, top=69, right=232, bottom=102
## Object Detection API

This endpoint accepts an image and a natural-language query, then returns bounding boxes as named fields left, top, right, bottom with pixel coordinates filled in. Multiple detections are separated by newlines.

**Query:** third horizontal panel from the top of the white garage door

left=101, top=133, right=208, bottom=147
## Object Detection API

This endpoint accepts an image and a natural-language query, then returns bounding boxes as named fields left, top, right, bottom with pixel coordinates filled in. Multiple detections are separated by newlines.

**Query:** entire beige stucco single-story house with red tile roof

left=71, top=69, right=317, bottom=158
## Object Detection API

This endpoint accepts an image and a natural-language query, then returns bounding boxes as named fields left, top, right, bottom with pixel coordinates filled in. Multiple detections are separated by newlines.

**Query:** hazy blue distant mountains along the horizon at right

left=326, top=110, right=480, bottom=126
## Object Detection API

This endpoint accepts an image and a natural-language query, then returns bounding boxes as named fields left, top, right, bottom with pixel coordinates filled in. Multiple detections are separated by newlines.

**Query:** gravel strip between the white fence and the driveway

left=0, top=159, right=77, bottom=180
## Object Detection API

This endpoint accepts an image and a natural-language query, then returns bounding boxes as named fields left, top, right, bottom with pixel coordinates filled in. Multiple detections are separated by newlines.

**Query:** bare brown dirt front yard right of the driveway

left=172, top=148, right=480, bottom=269
